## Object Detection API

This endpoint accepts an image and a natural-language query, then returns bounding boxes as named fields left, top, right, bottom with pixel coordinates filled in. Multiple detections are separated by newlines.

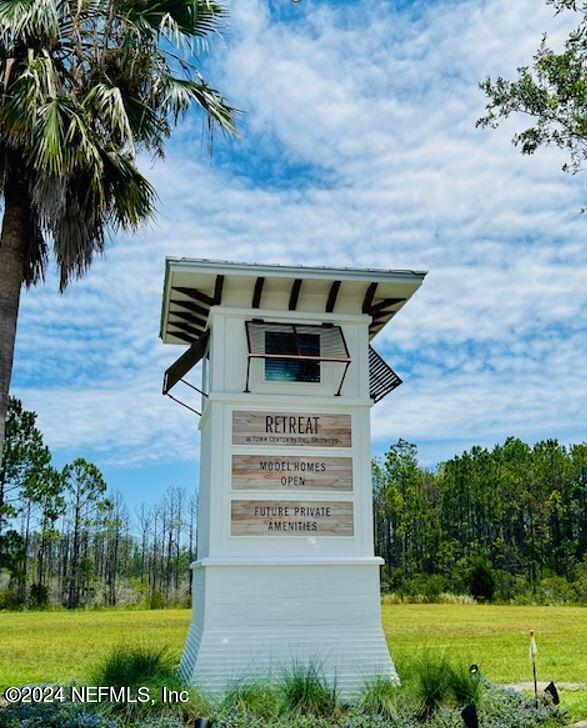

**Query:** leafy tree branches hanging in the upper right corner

left=477, top=0, right=587, bottom=172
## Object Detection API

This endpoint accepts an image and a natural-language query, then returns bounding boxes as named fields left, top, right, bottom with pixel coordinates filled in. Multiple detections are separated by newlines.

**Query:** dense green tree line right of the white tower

left=372, top=437, right=587, bottom=603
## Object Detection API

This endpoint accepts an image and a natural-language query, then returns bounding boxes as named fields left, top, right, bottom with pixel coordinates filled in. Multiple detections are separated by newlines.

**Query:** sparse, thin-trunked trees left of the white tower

left=0, top=398, right=198, bottom=609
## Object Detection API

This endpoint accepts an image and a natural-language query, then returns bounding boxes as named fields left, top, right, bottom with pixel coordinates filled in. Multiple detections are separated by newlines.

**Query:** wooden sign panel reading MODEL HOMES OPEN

left=232, top=455, right=353, bottom=491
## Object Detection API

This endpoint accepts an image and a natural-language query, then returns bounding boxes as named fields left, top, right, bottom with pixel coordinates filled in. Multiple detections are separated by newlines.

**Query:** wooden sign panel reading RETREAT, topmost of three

left=232, top=411, right=351, bottom=447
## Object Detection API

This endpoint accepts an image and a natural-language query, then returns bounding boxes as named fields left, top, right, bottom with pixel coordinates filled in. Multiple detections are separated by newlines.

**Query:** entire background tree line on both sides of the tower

left=0, top=398, right=587, bottom=609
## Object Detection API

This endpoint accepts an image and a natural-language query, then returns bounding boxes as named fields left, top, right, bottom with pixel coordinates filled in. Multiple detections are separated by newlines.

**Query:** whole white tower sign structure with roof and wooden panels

left=161, top=258, right=425, bottom=697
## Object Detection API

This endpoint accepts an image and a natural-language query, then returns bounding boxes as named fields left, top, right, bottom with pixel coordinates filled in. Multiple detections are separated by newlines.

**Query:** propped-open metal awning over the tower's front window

left=245, top=319, right=351, bottom=396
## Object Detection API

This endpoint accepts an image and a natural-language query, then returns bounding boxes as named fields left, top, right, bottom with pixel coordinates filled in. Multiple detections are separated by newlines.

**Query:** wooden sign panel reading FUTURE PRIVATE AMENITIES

left=230, top=500, right=355, bottom=537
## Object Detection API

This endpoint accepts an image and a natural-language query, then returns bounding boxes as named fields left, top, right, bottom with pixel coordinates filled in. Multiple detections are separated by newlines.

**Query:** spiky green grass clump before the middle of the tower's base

left=279, top=661, right=338, bottom=716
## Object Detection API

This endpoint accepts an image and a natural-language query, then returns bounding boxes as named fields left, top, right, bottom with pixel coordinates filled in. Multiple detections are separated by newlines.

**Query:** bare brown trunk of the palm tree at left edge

left=0, top=172, right=29, bottom=474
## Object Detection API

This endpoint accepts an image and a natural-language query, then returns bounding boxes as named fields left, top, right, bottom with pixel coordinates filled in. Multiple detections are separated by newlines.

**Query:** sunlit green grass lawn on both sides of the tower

left=0, top=604, right=587, bottom=717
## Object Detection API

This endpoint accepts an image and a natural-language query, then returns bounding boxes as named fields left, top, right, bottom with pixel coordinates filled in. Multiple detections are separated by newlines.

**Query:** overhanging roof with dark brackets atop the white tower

left=161, top=257, right=426, bottom=344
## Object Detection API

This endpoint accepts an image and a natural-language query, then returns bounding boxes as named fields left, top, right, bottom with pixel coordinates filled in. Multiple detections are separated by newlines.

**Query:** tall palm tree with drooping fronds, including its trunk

left=0, top=0, right=235, bottom=466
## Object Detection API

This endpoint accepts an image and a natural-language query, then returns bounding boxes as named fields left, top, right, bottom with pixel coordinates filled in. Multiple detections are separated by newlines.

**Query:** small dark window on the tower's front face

left=265, top=331, right=320, bottom=382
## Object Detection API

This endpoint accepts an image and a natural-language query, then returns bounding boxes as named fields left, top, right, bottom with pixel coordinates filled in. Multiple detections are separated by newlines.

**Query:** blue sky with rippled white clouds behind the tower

left=13, top=0, right=587, bottom=505
